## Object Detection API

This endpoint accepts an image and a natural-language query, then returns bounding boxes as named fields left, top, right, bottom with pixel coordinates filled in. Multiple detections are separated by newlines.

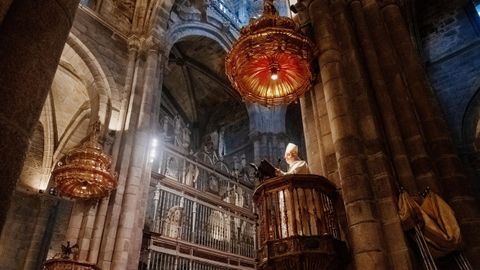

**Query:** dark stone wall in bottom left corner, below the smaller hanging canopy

left=0, top=192, right=71, bottom=270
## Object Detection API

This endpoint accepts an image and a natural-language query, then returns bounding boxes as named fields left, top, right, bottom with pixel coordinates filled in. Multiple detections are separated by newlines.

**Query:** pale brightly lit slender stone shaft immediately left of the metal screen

left=110, top=36, right=159, bottom=270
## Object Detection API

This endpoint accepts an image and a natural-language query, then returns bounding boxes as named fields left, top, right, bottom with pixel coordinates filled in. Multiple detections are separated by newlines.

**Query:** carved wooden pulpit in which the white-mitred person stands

left=253, top=174, right=348, bottom=270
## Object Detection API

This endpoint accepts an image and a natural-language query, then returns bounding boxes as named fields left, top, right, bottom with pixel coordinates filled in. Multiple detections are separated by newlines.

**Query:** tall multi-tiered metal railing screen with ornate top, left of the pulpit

left=140, top=141, right=256, bottom=270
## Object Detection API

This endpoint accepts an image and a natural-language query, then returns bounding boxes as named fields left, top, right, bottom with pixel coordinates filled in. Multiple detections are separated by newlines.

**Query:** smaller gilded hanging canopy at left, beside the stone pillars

left=52, top=123, right=117, bottom=199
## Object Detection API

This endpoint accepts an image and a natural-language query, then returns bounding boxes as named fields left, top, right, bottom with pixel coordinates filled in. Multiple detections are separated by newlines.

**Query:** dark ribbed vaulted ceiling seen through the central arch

left=163, top=36, right=241, bottom=133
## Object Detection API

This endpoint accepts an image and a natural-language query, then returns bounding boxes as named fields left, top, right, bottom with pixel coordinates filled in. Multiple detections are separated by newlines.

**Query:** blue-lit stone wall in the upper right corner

left=418, top=1, right=480, bottom=144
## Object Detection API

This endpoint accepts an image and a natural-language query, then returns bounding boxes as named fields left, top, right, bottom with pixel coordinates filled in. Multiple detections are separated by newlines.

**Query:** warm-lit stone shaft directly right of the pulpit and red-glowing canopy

left=309, top=0, right=388, bottom=269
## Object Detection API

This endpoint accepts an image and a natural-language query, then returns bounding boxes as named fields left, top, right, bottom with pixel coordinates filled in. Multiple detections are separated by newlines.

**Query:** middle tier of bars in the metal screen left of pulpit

left=146, top=185, right=255, bottom=258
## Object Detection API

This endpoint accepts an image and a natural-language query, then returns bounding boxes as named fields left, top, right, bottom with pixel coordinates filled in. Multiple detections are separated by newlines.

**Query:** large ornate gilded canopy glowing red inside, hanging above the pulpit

left=225, top=0, right=314, bottom=106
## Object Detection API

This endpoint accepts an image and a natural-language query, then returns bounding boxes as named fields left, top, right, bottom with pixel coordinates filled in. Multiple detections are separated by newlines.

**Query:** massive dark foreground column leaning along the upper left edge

left=0, top=0, right=79, bottom=231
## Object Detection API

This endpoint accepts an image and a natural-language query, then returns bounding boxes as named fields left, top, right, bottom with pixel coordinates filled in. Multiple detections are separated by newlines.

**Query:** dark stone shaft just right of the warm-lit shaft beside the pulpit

left=331, top=1, right=413, bottom=269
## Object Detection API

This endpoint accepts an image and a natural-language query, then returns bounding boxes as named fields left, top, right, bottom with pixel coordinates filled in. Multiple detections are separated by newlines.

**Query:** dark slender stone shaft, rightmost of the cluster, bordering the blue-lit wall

left=382, top=0, right=480, bottom=268
